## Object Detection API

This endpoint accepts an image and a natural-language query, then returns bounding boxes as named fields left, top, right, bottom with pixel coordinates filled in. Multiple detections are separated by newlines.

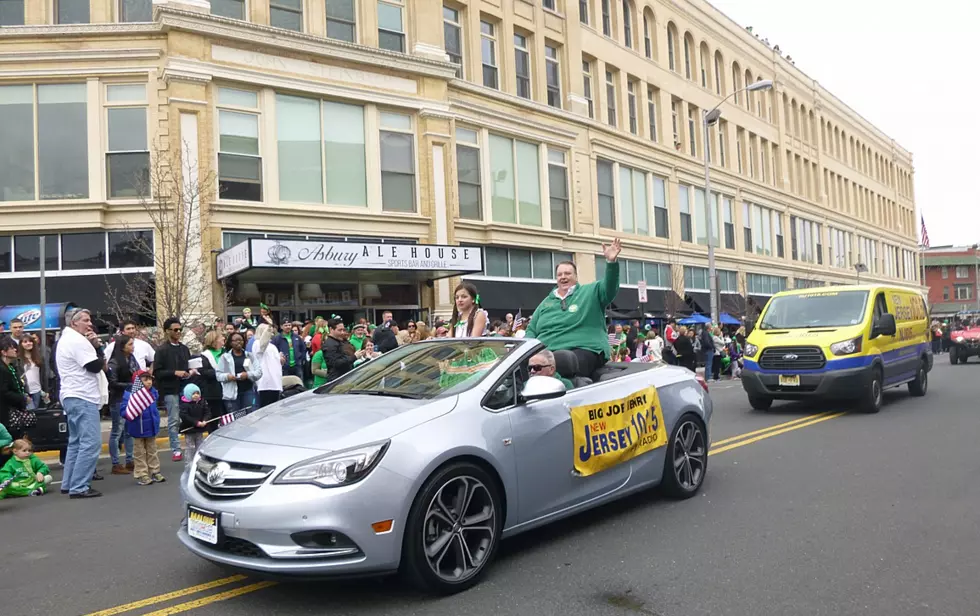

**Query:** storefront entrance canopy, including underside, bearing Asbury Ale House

left=217, top=238, right=483, bottom=282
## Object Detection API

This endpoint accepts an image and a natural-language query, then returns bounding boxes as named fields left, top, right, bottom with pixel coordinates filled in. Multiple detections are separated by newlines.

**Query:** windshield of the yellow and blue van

left=759, top=291, right=868, bottom=329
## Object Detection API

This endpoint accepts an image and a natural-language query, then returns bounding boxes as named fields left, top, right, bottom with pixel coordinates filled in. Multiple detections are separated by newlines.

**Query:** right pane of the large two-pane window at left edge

left=39, top=83, right=89, bottom=199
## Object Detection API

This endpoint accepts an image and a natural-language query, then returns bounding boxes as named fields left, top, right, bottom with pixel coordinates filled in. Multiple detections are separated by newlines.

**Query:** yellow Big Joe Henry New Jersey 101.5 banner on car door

left=570, top=387, right=667, bottom=477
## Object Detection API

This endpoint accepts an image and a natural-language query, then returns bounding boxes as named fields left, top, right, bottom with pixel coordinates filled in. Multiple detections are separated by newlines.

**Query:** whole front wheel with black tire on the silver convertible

left=402, top=462, right=504, bottom=595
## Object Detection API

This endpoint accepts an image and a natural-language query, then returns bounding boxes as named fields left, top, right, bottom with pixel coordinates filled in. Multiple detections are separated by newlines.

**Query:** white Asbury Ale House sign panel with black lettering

left=218, top=239, right=483, bottom=278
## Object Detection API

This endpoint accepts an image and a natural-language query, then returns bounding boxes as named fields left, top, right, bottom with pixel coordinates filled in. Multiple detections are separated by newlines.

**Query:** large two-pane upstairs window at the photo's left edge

left=0, top=83, right=89, bottom=201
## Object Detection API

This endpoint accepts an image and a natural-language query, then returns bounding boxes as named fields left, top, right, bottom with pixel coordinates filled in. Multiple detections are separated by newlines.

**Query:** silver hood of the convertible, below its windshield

left=218, top=392, right=458, bottom=451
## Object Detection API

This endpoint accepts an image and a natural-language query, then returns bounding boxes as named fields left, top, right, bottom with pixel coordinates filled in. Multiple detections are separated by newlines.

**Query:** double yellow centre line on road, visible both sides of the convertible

left=87, top=411, right=846, bottom=616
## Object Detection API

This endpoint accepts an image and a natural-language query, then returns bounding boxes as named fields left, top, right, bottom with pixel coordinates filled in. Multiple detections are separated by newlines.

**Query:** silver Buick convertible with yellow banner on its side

left=178, top=338, right=712, bottom=594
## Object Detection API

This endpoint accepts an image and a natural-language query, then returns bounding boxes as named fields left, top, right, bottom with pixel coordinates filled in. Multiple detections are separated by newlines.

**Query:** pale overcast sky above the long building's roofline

left=708, top=0, right=980, bottom=246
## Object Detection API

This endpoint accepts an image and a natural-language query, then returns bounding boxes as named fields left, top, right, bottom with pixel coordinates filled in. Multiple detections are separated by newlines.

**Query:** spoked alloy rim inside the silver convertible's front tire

left=422, top=475, right=497, bottom=583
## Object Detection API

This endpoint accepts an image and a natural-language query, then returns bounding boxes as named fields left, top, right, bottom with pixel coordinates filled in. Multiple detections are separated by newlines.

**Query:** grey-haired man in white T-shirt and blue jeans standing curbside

left=55, top=309, right=105, bottom=498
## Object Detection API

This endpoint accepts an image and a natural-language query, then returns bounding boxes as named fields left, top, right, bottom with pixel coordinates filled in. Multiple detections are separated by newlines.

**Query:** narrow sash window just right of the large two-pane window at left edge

left=106, top=83, right=150, bottom=199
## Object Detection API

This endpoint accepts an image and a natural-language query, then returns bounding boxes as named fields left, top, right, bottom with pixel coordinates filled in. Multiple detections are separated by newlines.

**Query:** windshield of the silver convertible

left=316, top=338, right=523, bottom=400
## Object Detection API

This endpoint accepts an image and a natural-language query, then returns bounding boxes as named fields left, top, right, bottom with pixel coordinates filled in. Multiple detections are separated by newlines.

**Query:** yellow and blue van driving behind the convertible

left=742, top=285, right=933, bottom=413
